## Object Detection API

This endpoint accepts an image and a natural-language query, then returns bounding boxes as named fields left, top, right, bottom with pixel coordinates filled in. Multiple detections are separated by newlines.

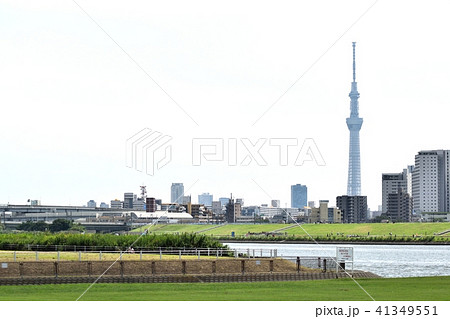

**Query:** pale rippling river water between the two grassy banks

left=225, top=242, right=450, bottom=277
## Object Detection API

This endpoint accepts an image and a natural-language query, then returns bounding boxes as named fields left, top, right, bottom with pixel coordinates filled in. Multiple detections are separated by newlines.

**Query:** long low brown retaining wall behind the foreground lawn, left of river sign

left=0, top=259, right=290, bottom=278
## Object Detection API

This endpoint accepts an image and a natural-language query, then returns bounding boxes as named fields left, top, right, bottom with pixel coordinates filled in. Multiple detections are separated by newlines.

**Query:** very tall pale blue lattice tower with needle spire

left=347, top=42, right=363, bottom=196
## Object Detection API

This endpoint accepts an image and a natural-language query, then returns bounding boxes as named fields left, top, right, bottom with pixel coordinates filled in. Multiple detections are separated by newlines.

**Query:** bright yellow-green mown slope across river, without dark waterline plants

left=131, top=223, right=450, bottom=237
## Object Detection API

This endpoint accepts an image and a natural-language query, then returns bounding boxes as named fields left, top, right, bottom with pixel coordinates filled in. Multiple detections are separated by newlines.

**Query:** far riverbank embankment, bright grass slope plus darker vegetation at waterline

left=131, top=223, right=450, bottom=242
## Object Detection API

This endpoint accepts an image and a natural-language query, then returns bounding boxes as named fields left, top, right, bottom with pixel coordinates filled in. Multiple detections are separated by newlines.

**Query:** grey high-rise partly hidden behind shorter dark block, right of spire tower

left=381, top=165, right=414, bottom=214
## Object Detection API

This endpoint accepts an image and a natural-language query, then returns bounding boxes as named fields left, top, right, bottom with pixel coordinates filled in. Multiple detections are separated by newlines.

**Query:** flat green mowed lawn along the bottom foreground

left=0, top=277, right=450, bottom=301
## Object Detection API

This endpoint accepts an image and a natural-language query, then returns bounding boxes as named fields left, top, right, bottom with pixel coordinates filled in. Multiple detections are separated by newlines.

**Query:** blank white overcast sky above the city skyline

left=0, top=0, right=450, bottom=209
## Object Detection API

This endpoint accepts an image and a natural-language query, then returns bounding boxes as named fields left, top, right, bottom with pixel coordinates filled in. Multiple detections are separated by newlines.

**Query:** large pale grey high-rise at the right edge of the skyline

left=412, top=150, right=450, bottom=213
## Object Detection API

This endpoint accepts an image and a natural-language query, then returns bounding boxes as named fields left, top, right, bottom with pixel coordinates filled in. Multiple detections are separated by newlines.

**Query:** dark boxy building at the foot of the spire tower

left=336, top=195, right=367, bottom=224
